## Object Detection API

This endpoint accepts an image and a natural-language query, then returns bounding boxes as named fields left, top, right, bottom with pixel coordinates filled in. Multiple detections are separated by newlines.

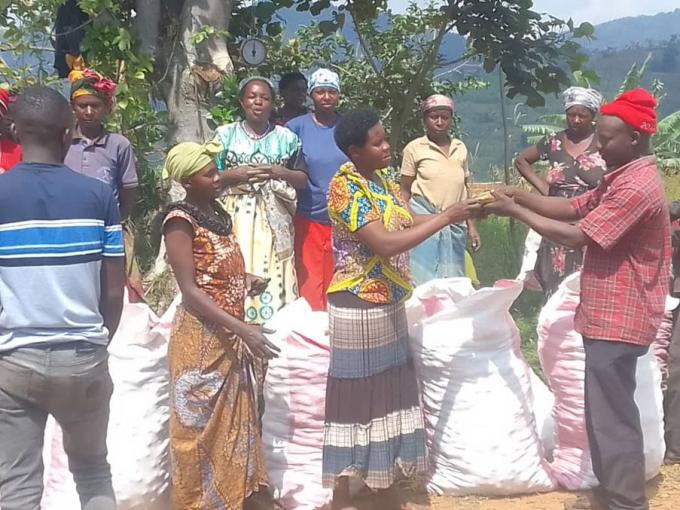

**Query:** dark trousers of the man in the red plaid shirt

left=583, top=338, right=649, bottom=510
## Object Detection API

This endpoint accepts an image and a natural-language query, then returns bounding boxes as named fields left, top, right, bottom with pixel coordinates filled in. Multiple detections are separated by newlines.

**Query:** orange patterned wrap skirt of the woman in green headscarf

left=168, top=306, right=267, bottom=510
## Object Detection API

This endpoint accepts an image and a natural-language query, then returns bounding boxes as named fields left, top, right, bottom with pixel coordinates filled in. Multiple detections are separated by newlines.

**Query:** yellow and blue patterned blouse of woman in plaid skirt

left=328, top=163, right=413, bottom=304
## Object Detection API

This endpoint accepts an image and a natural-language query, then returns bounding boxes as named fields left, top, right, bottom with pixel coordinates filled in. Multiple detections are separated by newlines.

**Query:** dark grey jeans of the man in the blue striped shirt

left=0, top=342, right=116, bottom=510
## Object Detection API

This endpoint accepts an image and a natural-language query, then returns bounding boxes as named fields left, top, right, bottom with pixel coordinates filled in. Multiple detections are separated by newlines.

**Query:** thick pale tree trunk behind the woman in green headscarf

left=156, top=0, right=234, bottom=144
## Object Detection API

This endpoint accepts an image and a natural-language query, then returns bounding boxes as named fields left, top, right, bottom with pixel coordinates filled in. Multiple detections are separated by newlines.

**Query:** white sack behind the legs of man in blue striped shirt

left=41, top=296, right=181, bottom=510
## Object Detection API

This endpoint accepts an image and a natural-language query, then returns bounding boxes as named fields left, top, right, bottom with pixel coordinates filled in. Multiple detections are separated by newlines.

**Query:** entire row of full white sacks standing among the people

left=34, top=277, right=663, bottom=510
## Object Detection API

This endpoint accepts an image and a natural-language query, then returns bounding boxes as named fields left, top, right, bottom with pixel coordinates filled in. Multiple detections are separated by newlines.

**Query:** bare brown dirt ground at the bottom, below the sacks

left=350, top=465, right=680, bottom=510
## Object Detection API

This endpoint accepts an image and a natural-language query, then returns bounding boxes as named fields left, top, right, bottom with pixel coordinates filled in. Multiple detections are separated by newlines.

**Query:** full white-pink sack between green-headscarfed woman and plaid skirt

left=262, top=299, right=332, bottom=510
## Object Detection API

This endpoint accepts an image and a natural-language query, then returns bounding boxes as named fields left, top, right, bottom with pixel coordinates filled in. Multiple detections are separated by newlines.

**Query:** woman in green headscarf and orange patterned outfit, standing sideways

left=163, top=142, right=276, bottom=510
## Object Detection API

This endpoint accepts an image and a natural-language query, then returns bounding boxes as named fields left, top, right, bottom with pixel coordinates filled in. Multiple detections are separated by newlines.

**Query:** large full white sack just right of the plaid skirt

left=406, top=278, right=555, bottom=496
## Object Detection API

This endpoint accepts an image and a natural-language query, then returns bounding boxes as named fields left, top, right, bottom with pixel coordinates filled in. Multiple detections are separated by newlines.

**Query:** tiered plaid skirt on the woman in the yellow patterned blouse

left=323, top=303, right=426, bottom=489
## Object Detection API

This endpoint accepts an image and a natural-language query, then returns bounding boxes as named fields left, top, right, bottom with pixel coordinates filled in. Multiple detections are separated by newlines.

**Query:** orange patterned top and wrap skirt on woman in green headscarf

left=164, top=209, right=267, bottom=510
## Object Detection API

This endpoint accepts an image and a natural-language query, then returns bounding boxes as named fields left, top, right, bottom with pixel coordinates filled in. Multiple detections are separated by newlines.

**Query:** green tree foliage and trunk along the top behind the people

left=0, top=0, right=592, bottom=221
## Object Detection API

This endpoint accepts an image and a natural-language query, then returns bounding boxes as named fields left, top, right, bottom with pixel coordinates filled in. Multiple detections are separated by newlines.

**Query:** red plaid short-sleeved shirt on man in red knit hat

left=571, top=156, right=671, bottom=345
